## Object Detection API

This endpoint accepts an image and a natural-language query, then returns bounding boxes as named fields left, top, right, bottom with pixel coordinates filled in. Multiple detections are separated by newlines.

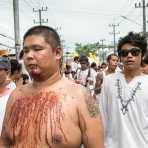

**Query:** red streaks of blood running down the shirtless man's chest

left=9, top=92, right=67, bottom=147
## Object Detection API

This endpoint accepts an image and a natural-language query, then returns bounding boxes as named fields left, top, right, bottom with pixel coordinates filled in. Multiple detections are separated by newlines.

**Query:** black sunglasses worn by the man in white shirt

left=118, top=47, right=141, bottom=57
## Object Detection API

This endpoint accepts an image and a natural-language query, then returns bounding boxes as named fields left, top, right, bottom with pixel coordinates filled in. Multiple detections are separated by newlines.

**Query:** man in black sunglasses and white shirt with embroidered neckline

left=100, top=32, right=148, bottom=148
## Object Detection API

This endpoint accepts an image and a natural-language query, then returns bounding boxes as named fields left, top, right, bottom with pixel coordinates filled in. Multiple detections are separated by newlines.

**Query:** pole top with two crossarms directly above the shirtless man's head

left=33, top=7, right=48, bottom=26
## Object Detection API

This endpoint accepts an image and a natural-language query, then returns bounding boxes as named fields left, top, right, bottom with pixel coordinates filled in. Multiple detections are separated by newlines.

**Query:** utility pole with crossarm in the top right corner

left=135, top=0, right=148, bottom=37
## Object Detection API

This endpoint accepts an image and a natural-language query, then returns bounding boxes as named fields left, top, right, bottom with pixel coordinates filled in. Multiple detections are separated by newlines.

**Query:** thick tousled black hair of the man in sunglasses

left=117, top=32, right=147, bottom=56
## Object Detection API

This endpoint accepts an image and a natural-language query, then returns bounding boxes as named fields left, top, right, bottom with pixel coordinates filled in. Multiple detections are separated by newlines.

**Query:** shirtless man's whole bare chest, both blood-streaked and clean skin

left=9, top=92, right=78, bottom=147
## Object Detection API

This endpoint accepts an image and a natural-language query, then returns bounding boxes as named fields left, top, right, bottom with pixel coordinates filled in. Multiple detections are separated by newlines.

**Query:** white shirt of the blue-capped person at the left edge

left=0, top=89, right=13, bottom=134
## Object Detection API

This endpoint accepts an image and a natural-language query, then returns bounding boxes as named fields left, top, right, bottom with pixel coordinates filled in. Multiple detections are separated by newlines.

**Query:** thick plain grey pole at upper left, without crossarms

left=13, top=0, right=20, bottom=59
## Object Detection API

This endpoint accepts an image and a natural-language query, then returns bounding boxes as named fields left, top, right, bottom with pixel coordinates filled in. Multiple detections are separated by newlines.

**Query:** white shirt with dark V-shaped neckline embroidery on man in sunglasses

left=99, top=72, right=148, bottom=148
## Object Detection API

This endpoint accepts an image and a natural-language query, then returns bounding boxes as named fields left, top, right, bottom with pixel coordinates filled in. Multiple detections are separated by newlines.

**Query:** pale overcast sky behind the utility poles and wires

left=0, top=0, right=148, bottom=49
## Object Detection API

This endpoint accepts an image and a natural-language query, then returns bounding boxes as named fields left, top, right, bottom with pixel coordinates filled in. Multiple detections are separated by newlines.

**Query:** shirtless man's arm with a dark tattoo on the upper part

left=78, top=90, right=104, bottom=148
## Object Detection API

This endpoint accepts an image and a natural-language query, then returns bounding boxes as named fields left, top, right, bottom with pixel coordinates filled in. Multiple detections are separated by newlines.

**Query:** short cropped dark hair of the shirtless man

left=23, top=26, right=61, bottom=50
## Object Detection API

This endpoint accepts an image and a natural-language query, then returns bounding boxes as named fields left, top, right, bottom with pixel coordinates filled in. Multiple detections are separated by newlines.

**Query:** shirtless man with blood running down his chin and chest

left=0, top=26, right=104, bottom=148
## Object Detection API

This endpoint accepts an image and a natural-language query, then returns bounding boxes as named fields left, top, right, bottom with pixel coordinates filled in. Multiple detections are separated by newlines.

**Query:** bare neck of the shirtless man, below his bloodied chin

left=32, top=72, right=61, bottom=88
